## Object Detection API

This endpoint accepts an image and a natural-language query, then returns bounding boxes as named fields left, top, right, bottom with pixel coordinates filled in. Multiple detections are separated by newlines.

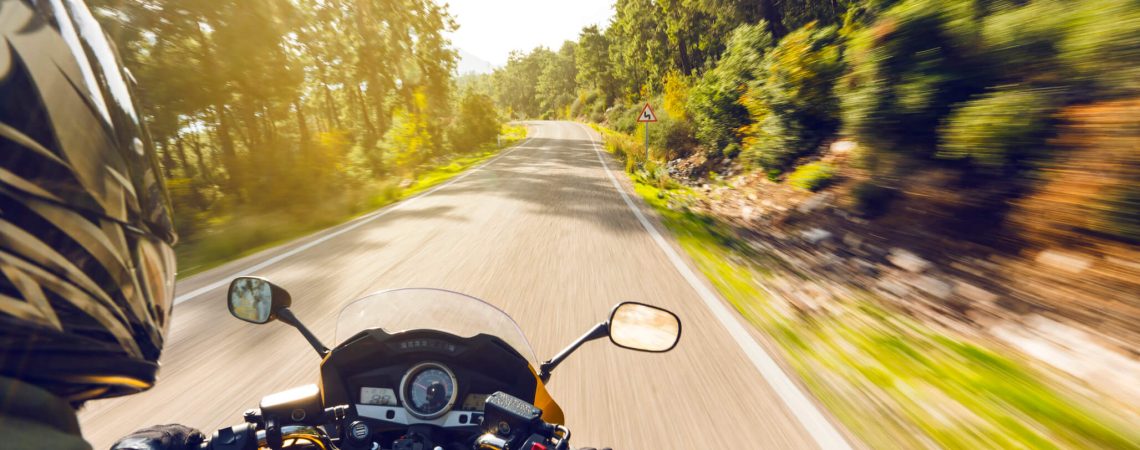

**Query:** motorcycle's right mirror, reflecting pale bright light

left=609, top=302, right=681, bottom=353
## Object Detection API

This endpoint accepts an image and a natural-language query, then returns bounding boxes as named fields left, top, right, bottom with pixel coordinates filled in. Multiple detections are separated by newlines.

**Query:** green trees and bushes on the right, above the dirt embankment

left=487, top=0, right=1140, bottom=242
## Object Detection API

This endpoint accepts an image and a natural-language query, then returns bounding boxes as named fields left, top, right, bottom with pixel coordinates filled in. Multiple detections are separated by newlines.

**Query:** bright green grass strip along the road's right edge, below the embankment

left=603, top=129, right=1140, bottom=449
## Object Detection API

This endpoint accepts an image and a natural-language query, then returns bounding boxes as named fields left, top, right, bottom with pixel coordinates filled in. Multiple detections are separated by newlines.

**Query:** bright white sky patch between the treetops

left=438, top=0, right=613, bottom=66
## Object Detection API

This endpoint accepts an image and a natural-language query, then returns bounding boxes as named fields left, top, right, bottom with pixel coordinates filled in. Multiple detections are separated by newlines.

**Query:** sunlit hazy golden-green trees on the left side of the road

left=90, top=0, right=510, bottom=267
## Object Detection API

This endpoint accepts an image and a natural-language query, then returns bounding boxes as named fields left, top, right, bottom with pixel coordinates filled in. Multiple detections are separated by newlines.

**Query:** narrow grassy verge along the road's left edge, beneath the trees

left=174, top=125, right=527, bottom=279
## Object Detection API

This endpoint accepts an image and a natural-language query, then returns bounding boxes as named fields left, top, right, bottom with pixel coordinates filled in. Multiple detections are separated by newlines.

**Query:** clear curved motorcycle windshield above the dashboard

left=336, top=288, right=538, bottom=367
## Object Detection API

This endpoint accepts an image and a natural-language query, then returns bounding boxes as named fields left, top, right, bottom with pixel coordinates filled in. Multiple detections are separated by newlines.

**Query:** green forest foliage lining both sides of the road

left=91, top=0, right=1140, bottom=254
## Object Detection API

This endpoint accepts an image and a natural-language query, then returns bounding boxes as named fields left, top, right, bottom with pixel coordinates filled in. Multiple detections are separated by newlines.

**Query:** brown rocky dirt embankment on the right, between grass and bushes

left=669, top=100, right=1140, bottom=407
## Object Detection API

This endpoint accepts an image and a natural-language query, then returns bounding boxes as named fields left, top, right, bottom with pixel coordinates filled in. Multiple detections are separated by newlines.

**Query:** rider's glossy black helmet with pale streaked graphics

left=0, top=0, right=176, bottom=403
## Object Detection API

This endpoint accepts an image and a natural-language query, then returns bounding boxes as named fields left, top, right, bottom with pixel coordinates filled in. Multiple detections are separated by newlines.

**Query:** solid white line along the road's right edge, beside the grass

left=578, top=123, right=850, bottom=450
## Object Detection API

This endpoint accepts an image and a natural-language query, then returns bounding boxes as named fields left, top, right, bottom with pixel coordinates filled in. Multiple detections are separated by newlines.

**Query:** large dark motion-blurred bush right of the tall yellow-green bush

left=839, top=0, right=988, bottom=157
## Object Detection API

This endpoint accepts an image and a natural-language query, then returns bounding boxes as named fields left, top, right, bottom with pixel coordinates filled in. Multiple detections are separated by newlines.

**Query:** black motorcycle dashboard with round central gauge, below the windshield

left=323, top=330, right=537, bottom=433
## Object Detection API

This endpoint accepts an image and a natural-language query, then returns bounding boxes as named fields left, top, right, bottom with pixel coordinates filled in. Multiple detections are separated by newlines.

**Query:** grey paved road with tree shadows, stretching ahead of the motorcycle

left=81, top=122, right=848, bottom=450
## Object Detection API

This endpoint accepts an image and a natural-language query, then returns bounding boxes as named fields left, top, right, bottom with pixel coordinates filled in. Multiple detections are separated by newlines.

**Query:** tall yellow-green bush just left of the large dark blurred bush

left=741, top=24, right=842, bottom=169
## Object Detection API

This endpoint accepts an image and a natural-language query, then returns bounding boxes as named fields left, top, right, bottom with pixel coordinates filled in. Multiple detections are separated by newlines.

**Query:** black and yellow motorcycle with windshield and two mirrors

left=202, top=277, right=681, bottom=450
